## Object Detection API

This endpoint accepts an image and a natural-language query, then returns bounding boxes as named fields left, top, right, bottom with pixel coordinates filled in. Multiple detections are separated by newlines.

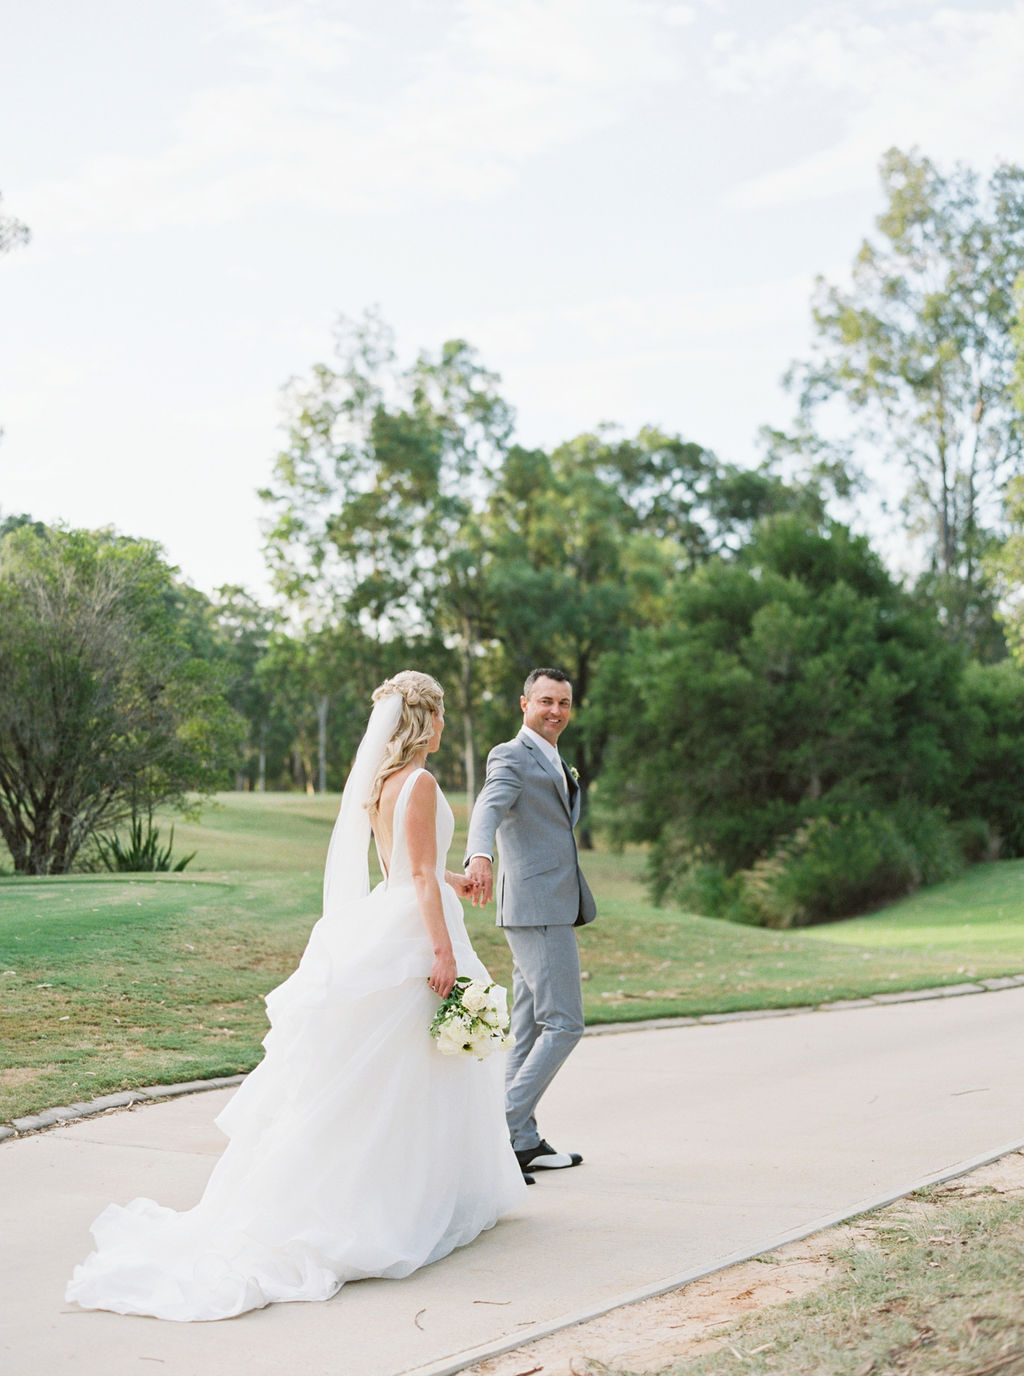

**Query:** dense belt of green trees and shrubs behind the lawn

left=0, top=151, right=1024, bottom=926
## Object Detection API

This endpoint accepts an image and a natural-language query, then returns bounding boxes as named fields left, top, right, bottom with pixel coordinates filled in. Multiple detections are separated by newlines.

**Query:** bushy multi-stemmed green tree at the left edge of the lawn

left=0, top=526, right=244, bottom=874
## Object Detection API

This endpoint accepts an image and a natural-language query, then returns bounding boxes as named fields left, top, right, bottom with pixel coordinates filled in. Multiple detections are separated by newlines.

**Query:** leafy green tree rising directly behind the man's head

left=482, top=427, right=823, bottom=845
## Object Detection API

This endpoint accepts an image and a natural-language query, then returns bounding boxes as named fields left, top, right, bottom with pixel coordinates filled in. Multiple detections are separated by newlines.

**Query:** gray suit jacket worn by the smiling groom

left=467, top=733, right=597, bottom=927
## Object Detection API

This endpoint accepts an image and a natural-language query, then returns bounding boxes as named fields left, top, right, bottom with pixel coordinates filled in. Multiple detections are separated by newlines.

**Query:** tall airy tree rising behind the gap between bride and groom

left=260, top=312, right=512, bottom=791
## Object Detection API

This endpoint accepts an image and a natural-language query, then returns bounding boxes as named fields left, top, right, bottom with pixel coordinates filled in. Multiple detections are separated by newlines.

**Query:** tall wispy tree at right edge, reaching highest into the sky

left=789, top=149, right=1024, bottom=655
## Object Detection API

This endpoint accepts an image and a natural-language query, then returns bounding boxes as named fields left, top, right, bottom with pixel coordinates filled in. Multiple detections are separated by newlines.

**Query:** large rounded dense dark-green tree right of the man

left=597, top=513, right=1024, bottom=921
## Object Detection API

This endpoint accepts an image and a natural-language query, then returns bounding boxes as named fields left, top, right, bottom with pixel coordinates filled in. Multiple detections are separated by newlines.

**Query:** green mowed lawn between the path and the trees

left=0, top=794, right=1024, bottom=1121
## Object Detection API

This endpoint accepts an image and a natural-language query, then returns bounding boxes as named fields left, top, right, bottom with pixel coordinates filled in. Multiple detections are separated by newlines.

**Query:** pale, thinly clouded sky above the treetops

left=0, top=0, right=1024, bottom=592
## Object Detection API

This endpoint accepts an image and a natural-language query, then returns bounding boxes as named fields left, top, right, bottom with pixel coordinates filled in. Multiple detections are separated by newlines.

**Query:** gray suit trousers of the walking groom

left=504, top=923, right=584, bottom=1152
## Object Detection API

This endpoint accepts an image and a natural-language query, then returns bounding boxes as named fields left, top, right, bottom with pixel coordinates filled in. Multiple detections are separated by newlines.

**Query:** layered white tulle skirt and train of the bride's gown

left=67, top=886, right=526, bottom=1321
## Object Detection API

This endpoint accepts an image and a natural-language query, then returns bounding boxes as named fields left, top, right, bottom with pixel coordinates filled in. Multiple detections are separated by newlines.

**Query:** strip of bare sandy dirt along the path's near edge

left=462, top=1152, right=1024, bottom=1376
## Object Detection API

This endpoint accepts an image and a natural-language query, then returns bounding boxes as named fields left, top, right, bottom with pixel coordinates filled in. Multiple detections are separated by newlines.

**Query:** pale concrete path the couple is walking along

left=0, top=988, right=1024, bottom=1376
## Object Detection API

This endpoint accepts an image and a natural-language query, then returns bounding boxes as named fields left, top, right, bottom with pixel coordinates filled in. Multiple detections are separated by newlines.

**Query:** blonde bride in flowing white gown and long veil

left=67, top=670, right=526, bottom=1320
